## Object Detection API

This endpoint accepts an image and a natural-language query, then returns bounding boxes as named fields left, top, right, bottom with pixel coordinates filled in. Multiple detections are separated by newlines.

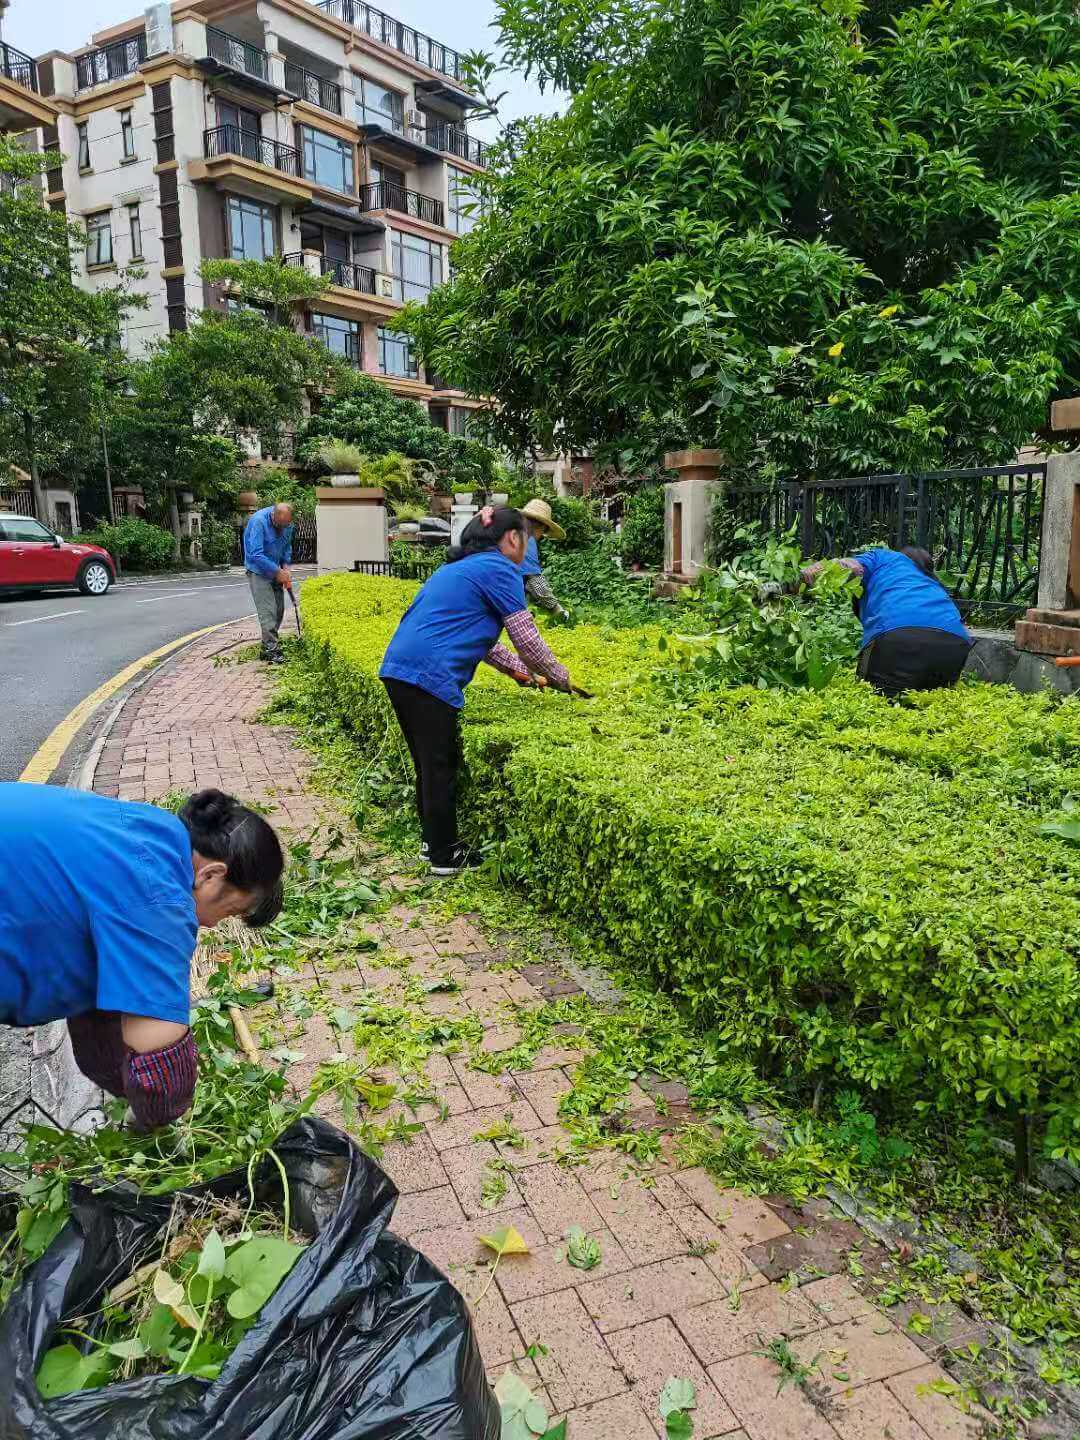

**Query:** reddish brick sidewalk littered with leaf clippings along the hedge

left=95, top=624, right=984, bottom=1440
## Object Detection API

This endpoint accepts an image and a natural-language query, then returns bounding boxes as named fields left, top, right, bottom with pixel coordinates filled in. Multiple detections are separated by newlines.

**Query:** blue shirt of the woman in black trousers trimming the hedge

left=379, top=550, right=526, bottom=710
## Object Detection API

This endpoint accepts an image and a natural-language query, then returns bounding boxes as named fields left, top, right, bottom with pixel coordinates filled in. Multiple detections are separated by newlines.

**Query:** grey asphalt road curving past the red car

left=0, top=572, right=292, bottom=780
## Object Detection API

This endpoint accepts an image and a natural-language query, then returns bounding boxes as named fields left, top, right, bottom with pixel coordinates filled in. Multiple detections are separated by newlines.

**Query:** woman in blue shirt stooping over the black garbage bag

left=0, top=783, right=285, bottom=1129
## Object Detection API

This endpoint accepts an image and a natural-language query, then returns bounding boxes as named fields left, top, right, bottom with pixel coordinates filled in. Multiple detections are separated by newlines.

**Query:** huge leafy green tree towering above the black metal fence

left=405, top=0, right=1080, bottom=475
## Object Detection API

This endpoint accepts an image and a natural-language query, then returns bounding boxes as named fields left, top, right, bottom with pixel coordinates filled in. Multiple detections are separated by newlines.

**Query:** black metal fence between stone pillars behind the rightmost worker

left=724, top=462, right=1047, bottom=619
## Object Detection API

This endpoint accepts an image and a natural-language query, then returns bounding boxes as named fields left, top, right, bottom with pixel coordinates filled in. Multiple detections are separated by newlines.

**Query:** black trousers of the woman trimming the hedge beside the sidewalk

left=383, top=680, right=461, bottom=865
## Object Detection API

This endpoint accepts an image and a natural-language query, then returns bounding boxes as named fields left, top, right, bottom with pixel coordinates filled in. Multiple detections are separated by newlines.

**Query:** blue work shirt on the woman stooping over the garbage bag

left=0, top=783, right=199, bottom=1025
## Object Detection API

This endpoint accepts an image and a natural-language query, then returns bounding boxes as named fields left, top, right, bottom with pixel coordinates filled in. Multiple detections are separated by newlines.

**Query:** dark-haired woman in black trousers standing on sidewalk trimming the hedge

left=379, top=507, right=570, bottom=876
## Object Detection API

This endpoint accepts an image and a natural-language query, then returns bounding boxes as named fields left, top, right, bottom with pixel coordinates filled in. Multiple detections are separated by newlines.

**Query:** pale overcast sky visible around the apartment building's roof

left=3, top=0, right=559, bottom=135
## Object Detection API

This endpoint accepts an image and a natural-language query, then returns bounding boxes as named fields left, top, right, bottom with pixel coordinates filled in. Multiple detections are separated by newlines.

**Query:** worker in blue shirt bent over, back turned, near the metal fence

left=802, top=546, right=971, bottom=697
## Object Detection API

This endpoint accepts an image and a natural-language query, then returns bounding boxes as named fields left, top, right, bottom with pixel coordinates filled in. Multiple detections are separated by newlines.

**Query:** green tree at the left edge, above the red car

left=0, top=135, right=141, bottom=517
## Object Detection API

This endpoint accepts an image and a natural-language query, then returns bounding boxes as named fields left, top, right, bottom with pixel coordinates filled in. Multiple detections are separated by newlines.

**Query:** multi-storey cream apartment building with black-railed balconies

left=0, top=0, right=487, bottom=432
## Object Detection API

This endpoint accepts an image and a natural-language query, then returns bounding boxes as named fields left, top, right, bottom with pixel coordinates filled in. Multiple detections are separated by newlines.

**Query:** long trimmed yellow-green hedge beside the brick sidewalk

left=302, top=576, right=1080, bottom=1156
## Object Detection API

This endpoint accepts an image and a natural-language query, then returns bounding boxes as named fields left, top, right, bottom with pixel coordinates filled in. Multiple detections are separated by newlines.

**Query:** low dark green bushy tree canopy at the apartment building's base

left=301, top=369, right=498, bottom=494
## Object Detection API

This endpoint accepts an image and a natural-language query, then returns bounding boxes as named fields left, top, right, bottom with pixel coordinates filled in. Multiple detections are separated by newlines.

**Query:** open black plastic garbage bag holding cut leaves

left=0, top=1116, right=500, bottom=1440
